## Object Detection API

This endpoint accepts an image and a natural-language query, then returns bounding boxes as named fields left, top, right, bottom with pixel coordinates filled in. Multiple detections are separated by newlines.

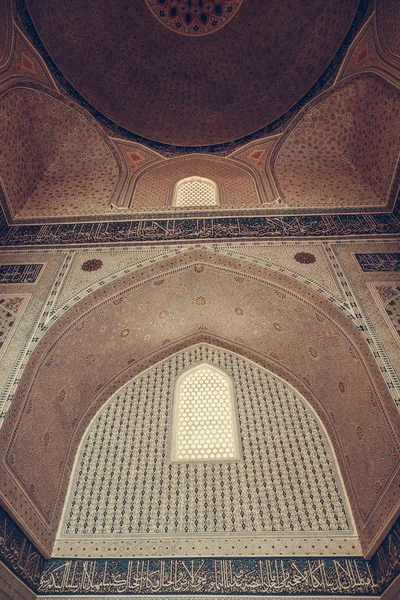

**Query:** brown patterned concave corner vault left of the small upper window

left=0, top=88, right=119, bottom=219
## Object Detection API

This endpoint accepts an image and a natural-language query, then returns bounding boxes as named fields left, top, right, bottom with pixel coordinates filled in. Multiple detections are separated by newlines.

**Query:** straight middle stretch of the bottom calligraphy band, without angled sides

left=38, top=558, right=380, bottom=596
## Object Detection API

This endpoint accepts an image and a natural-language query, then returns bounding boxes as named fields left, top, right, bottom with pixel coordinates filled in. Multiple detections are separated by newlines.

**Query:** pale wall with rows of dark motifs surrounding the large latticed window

left=60, top=344, right=349, bottom=537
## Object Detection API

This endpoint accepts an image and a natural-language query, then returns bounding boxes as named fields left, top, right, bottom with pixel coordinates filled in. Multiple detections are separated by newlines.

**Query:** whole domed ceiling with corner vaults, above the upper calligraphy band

left=0, top=0, right=400, bottom=224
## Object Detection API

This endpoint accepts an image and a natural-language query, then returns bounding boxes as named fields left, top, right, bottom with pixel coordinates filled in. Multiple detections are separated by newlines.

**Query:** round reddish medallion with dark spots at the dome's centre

left=145, top=0, right=243, bottom=36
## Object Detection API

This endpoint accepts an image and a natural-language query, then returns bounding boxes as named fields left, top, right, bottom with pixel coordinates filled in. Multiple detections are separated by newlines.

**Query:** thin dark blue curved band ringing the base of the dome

left=15, top=0, right=374, bottom=156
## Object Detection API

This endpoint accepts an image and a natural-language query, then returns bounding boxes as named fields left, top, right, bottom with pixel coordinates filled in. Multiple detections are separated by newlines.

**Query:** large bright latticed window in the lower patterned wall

left=172, top=363, right=240, bottom=462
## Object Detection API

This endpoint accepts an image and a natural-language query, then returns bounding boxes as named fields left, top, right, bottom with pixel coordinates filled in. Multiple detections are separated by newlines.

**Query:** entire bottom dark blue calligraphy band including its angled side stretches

left=0, top=454, right=400, bottom=597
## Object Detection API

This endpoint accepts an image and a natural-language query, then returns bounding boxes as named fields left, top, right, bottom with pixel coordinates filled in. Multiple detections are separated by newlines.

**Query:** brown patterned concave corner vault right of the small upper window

left=271, top=74, right=400, bottom=208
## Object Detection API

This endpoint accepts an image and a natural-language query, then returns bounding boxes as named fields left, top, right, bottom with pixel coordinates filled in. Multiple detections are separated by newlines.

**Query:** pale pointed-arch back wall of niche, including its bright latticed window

left=55, top=343, right=357, bottom=557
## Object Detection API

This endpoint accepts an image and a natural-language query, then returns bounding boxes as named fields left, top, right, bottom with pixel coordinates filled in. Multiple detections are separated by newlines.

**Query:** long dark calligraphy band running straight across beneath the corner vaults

left=0, top=206, right=400, bottom=247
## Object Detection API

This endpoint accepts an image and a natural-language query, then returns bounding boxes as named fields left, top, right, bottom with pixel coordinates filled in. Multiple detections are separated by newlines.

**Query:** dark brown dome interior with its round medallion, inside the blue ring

left=26, top=0, right=359, bottom=146
